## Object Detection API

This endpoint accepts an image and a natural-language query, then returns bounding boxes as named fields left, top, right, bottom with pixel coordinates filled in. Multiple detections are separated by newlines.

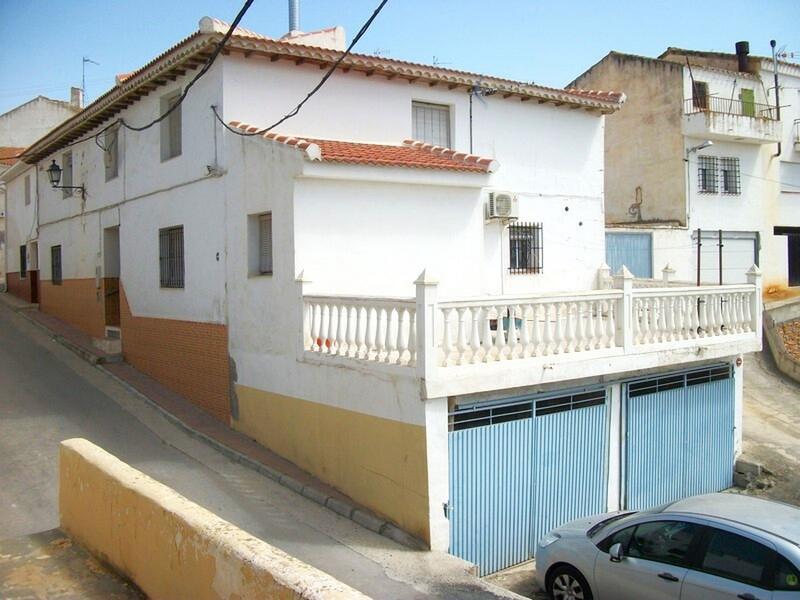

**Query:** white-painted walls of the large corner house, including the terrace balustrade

left=1, top=21, right=760, bottom=549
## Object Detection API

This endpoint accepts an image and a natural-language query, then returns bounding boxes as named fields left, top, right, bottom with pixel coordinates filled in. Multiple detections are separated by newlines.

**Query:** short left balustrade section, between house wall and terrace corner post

left=303, top=296, right=417, bottom=366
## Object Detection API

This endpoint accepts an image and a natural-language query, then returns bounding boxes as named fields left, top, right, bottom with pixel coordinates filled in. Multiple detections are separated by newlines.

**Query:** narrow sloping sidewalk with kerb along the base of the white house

left=0, top=293, right=426, bottom=549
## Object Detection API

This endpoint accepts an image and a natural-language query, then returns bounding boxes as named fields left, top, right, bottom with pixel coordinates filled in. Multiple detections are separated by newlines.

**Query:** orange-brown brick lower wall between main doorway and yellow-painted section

left=120, top=285, right=230, bottom=425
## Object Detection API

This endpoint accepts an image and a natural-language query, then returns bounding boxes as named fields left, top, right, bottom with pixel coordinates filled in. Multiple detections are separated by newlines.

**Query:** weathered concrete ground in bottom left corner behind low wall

left=0, top=529, right=145, bottom=600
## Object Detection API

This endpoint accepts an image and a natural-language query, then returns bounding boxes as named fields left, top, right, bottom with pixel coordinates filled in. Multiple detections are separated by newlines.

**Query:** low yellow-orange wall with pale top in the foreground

left=59, top=439, right=366, bottom=600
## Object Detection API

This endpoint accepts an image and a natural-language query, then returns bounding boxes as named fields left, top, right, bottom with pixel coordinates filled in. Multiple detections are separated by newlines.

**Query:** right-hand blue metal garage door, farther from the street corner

left=625, top=364, right=735, bottom=510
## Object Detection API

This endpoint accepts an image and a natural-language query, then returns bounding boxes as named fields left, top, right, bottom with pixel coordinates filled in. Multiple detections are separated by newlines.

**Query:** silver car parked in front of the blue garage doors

left=536, top=494, right=800, bottom=600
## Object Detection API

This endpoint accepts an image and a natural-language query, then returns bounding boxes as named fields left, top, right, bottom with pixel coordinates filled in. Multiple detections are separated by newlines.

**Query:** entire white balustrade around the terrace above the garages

left=301, top=282, right=760, bottom=376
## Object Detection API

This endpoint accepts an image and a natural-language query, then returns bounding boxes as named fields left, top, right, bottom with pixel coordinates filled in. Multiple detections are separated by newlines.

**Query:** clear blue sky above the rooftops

left=0, top=0, right=800, bottom=114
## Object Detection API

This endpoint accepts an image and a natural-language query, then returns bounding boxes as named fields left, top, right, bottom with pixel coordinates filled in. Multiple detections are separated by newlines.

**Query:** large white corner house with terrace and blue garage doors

left=0, top=18, right=761, bottom=573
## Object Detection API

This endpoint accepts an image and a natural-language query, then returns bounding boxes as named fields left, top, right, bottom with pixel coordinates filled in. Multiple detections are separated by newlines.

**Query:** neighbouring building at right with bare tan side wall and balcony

left=571, top=43, right=800, bottom=297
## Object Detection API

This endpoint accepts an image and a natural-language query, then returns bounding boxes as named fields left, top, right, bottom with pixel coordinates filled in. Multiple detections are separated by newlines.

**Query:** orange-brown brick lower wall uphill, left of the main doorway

left=39, top=277, right=105, bottom=338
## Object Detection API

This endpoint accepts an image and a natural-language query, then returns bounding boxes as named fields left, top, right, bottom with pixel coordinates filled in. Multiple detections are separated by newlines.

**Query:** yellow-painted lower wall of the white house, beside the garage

left=233, top=386, right=430, bottom=542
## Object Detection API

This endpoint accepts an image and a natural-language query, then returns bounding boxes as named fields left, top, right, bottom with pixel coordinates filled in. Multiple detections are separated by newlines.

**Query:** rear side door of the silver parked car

left=681, top=526, right=776, bottom=600
